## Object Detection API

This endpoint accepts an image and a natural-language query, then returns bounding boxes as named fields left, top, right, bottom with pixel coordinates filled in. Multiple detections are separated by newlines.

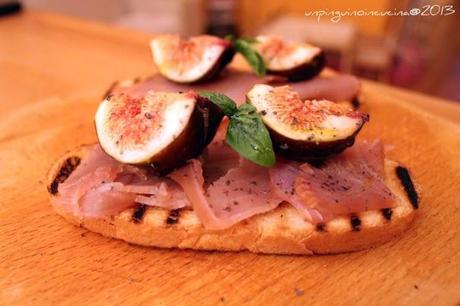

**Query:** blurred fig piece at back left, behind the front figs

left=150, top=35, right=235, bottom=83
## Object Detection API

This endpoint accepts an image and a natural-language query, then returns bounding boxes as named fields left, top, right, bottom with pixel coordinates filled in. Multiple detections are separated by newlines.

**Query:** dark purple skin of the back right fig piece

left=267, top=51, right=326, bottom=82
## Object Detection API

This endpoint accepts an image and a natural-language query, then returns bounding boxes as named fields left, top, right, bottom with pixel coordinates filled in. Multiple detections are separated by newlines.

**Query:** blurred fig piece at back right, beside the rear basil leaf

left=254, top=36, right=326, bottom=81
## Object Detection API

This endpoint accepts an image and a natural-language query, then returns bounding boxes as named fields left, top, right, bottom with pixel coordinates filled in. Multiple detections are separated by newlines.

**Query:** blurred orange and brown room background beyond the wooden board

left=3, top=0, right=460, bottom=102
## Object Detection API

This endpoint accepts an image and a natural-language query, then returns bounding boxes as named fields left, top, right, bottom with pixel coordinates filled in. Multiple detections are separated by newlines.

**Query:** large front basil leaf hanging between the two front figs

left=226, top=103, right=276, bottom=167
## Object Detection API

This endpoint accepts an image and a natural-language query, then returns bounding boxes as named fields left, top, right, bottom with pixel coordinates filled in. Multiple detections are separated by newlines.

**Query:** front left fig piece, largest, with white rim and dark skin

left=95, top=91, right=223, bottom=174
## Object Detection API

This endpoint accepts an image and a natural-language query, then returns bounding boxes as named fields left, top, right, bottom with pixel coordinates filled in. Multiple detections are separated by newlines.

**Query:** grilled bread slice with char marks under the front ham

left=47, top=147, right=417, bottom=255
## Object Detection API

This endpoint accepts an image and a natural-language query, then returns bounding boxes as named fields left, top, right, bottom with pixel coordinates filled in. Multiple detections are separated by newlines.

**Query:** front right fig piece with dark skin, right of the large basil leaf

left=247, top=84, right=369, bottom=161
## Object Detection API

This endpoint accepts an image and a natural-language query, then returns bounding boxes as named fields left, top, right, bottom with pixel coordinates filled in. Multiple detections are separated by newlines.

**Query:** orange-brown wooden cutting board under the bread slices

left=0, top=13, right=460, bottom=305
